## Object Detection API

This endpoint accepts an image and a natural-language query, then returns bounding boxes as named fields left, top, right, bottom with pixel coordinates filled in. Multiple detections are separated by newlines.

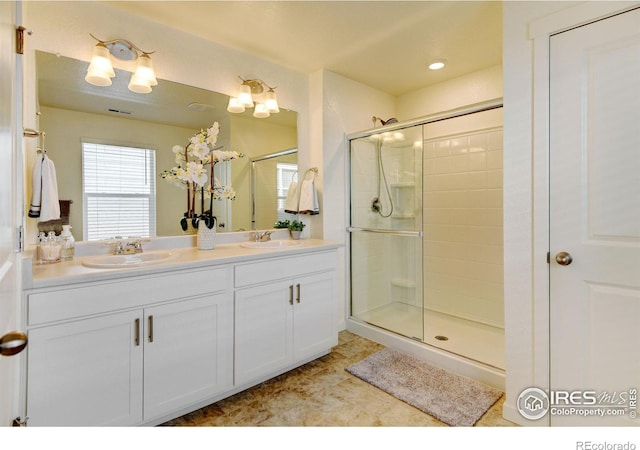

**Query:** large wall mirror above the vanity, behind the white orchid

left=36, top=51, right=297, bottom=240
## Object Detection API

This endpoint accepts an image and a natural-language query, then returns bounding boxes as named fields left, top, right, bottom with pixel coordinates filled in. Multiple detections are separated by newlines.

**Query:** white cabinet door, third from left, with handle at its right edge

left=235, top=281, right=293, bottom=386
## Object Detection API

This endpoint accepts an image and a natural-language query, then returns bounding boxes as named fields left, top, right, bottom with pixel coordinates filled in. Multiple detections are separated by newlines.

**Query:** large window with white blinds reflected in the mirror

left=82, top=142, right=156, bottom=241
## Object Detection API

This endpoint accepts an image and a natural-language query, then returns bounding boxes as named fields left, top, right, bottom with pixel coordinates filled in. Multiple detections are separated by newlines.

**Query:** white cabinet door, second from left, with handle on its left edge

left=144, top=293, right=233, bottom=421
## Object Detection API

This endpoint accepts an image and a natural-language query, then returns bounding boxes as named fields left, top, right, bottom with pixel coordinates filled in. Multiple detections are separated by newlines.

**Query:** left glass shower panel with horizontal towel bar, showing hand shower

left=349, top=126, right=424, bottom=340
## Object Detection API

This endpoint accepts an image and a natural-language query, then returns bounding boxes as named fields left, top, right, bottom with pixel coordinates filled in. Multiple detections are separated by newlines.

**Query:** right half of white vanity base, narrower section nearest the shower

left=234, top=251, right=337, bottom=386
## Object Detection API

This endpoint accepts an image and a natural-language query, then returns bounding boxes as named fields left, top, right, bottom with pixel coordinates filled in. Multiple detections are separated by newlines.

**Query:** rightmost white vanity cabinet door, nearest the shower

left=293, top=272, right=338, bottom=359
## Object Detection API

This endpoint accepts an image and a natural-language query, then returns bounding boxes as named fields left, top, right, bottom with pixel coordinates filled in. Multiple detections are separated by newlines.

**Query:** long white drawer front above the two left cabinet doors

left=27, top=267, right=229, bottom=325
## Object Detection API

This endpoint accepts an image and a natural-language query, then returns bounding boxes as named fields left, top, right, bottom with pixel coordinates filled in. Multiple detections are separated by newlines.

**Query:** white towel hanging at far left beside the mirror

left=29, top=153, right=60, bottom=222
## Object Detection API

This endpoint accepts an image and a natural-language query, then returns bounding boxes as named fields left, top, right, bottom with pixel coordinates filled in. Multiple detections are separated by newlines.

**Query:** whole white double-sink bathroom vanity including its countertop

left=21, top=239, right=339, bottom=426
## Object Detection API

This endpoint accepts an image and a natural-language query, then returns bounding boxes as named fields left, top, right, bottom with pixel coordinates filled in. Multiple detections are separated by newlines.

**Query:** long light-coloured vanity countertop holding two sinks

left=23, top=239, right=343, bottom=289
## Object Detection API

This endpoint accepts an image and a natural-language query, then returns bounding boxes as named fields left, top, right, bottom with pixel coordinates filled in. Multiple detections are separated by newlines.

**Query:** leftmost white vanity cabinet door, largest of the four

left=27, top=311, right=142, bottom=426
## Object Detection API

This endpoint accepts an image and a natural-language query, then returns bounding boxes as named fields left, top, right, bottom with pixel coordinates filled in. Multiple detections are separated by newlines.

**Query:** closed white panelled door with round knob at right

left=549, top=9, right=640, bottom=426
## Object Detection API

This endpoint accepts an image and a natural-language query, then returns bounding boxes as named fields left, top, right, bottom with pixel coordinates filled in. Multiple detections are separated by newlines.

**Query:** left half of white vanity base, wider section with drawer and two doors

left=26, top=267, right=233, bottom=426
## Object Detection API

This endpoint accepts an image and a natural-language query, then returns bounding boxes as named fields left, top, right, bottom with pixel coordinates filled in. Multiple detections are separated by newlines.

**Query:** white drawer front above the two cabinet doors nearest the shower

left=234, top=251, right=336, bottom=287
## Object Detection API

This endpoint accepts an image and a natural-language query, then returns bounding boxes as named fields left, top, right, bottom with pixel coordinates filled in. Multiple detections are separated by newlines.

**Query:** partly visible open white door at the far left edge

left=0, top=2, right=22, bottom=426
